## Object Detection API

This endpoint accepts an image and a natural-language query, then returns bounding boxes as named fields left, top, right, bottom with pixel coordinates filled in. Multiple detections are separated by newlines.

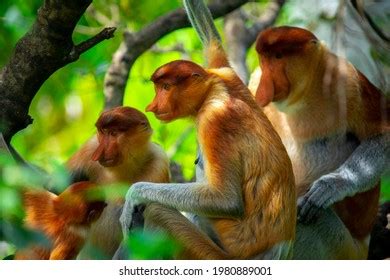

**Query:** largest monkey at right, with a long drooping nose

left=250, top=26, right=390, bottom=258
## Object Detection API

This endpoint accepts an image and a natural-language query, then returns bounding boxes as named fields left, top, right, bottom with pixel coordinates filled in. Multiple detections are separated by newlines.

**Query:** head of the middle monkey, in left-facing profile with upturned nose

left=146, top=60, right=209, bottom=122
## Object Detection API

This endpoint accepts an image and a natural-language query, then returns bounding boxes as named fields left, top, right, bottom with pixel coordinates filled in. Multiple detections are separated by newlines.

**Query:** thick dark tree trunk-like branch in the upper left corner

left=0, top=0, right=116, bottom=140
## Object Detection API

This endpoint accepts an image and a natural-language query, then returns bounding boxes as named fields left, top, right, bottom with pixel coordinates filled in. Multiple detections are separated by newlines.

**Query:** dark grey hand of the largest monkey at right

left=298, top=173, right=353, bottom=224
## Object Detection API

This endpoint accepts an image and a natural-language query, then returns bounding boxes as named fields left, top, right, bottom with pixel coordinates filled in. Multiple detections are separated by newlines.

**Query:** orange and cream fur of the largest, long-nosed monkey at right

left=251, top=27, right=390, bottom=239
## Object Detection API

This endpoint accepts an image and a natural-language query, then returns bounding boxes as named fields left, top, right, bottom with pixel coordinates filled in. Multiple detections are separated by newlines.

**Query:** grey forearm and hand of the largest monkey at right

left=298, top=132, right=390, bottom=223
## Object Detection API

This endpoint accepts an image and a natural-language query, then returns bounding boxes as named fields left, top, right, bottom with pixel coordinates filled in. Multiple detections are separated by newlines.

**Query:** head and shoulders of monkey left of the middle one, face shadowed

left=67, top=107, right=170, bottom=184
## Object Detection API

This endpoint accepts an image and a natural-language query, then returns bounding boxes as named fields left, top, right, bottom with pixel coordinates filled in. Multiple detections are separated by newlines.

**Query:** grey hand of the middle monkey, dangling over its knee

left=119, top=183, right=144, bottom=236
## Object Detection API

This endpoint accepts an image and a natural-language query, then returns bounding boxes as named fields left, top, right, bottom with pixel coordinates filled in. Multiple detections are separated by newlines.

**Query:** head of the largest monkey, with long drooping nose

left=256, top=26, right=322, bottom=106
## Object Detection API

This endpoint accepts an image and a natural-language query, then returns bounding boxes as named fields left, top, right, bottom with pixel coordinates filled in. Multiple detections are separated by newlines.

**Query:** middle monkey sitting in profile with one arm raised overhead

left=116, top=0, right=296, bottom=259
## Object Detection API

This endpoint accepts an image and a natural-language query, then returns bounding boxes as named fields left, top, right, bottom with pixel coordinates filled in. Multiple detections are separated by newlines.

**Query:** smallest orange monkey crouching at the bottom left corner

left=15, top=182, right=106, bottom=260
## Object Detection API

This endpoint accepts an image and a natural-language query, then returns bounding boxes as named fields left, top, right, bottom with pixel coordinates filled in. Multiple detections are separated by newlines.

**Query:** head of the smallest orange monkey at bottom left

left=53, top=181, right=107, bottom=225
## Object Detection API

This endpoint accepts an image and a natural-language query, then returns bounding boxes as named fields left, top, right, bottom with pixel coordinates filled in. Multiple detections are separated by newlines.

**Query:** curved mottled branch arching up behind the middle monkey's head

left=104, top=0, right=248, bottom=108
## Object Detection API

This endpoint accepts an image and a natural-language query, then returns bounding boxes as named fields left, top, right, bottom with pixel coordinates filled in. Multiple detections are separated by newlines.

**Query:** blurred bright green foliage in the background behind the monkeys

left=0, top=0, right=390, bottom=259
